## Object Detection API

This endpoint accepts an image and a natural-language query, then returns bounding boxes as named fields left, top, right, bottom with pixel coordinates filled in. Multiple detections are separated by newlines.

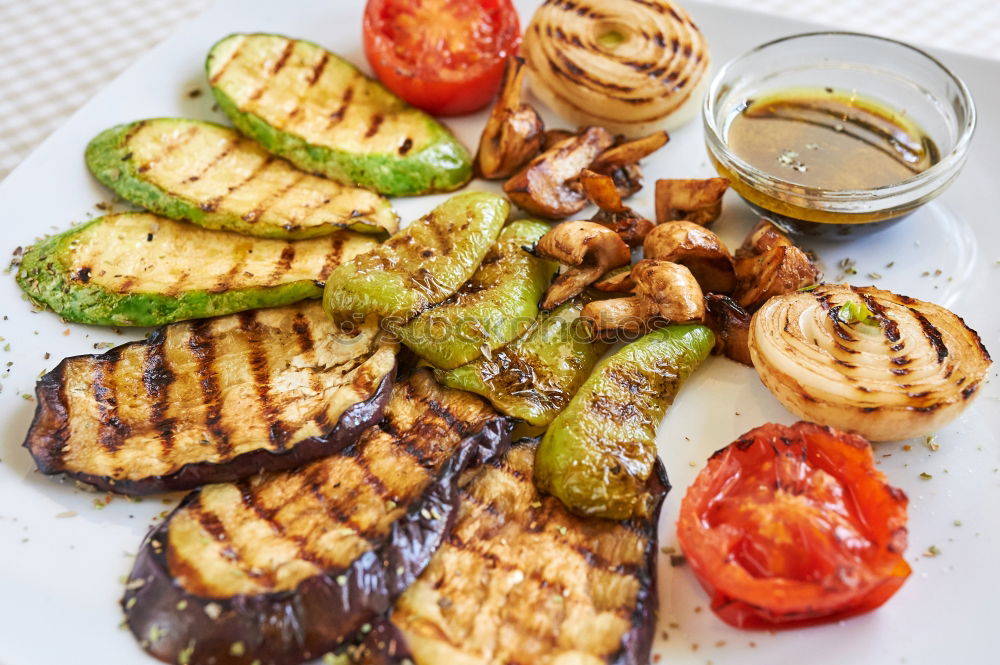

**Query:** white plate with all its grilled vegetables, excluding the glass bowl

left=0, top=0, right=1000, bottom=665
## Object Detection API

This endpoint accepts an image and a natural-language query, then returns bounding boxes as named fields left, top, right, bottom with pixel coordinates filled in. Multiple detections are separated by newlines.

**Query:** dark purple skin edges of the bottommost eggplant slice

left=360, top=452, right=670, bottom=665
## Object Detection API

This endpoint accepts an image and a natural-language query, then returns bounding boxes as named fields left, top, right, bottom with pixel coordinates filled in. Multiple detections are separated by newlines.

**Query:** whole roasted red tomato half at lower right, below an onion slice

left=677, top=422, right=910, bottom=628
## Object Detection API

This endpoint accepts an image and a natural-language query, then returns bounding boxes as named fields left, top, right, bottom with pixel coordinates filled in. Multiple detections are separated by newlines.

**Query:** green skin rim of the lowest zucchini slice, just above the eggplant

left=17, top=213, right=377, bottom=326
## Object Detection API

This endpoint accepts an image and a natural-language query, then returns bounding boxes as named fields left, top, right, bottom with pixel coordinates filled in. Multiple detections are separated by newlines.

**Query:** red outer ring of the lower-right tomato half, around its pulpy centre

left=677, top=422, right=910, bottom=629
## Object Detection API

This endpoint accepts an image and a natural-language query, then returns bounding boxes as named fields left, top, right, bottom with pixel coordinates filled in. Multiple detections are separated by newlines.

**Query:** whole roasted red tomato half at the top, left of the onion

left=364, top=0, right=521, bottom=115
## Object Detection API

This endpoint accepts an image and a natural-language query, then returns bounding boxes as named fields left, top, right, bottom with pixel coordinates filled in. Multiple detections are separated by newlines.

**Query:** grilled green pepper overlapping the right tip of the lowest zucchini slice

left=323, top=192, right=510, bottom=330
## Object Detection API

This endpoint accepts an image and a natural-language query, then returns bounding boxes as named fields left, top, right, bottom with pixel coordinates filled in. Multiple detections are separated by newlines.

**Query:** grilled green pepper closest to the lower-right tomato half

left=535, top=325, right=715, bottom=520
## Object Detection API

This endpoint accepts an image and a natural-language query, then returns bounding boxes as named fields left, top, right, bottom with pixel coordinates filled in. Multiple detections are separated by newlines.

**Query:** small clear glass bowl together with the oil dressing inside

left=702, top=32, right=976, bottom=237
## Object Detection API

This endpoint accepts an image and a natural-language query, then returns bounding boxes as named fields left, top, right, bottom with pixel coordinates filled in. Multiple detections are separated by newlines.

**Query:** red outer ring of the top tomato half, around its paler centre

left=363, top=0, right=521, bottom=116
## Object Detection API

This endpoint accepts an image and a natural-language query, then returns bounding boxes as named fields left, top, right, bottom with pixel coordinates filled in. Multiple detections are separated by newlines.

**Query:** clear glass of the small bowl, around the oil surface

left=702, top=32, right=976, bottom=237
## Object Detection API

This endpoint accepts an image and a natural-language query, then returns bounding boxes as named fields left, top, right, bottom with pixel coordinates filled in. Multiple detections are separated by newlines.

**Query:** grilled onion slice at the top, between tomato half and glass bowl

left=521, top=0, right=709, bottom=138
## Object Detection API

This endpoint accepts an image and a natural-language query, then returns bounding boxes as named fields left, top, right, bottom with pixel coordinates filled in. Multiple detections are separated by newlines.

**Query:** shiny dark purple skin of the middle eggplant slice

left=122, top=416, right=513, bottom=665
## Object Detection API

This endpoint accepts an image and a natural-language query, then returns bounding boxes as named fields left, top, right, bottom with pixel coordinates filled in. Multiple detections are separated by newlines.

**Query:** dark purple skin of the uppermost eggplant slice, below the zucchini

left=22, top=364, right=396, bottom=496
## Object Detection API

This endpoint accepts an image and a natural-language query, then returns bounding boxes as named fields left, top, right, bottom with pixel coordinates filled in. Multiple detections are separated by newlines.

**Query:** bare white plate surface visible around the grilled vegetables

left=0, top=0, right=1000, bottom=665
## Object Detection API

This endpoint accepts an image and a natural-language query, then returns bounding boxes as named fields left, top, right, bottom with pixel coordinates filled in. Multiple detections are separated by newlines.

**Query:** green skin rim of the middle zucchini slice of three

left=85, top=118, right=398, bottom=240
